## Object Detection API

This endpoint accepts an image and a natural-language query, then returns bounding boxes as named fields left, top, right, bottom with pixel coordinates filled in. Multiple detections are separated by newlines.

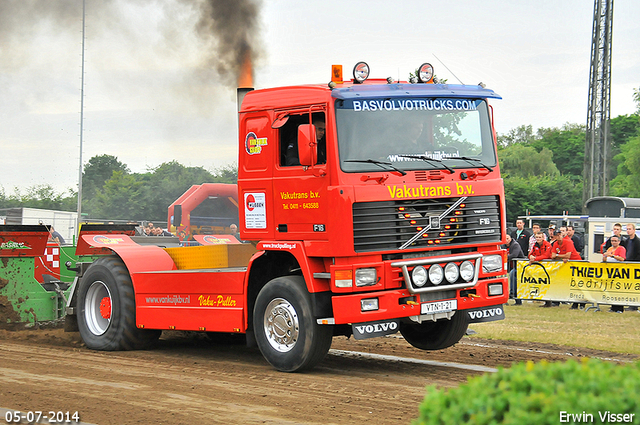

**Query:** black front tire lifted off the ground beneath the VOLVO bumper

left=400, top=311, right=469, bottom=350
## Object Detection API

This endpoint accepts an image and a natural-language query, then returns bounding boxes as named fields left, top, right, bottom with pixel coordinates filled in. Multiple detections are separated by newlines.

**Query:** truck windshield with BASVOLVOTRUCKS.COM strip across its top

left=336, top=97, right=496, bottom=172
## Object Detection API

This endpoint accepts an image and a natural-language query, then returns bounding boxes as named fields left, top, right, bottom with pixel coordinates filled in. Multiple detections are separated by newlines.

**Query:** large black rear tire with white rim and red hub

left=77, top=256, right=162, bottom=351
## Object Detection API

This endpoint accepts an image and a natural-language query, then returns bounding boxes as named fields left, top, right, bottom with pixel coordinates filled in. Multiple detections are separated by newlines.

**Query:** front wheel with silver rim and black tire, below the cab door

left=253, top=276, right=333, bottom=372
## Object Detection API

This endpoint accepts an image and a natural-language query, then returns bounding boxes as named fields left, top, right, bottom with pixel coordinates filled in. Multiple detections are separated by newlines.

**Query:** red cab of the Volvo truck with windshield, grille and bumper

left=238, top=61, right=508, bottom=336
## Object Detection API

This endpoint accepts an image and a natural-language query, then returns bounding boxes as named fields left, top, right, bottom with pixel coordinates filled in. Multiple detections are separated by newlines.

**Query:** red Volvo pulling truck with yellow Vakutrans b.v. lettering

left=67, top=63, right=508, bottom=372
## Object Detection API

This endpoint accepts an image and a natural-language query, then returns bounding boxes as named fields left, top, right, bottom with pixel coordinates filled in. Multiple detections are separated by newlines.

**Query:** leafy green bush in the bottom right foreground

left=414, top=358, right=640, bottom=425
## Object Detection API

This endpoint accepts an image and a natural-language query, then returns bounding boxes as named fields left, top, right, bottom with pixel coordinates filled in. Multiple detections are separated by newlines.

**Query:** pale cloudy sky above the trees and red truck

left=0, top=0, right=640, bottom=194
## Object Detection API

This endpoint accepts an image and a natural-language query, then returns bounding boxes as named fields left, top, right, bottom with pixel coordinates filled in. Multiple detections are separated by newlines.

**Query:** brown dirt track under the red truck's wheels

left=0, top=329, right=634, bottom=425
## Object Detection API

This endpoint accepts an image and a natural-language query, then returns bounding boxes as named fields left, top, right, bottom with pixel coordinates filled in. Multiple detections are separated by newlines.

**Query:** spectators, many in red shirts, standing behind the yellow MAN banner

left=504, top=220, right=640, bottom=313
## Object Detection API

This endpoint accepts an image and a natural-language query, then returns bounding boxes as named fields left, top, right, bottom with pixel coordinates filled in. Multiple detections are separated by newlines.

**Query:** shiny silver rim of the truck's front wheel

left=264, top=298, right=300, bottom=353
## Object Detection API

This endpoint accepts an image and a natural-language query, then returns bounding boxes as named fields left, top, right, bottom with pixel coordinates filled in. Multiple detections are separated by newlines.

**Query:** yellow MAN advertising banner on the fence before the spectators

left=517, top=261, right=640, bottom=306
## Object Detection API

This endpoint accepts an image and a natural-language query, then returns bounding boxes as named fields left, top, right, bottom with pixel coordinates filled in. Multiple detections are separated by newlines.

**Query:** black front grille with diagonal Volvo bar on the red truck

left=353, top=196, right=501, bottom=252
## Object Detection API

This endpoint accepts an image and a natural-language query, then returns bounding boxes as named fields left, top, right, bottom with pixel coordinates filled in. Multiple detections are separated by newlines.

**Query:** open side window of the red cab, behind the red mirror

left=279, top=112, right=327, bottom=167
